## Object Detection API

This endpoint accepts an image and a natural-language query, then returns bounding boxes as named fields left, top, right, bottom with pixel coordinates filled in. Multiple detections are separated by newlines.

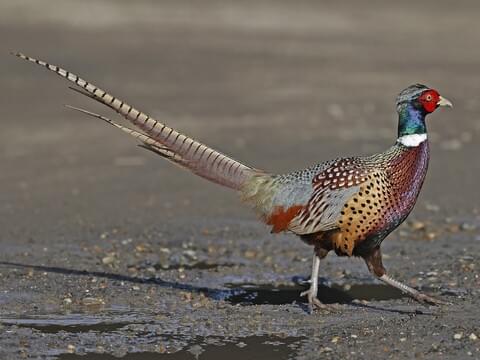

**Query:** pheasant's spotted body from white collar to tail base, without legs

left=244, top=141, right=429, bottom=255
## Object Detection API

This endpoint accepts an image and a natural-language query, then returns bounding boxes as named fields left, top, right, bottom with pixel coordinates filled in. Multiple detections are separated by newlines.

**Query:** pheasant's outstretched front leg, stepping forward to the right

left=364, top=247, right=448, bottom=305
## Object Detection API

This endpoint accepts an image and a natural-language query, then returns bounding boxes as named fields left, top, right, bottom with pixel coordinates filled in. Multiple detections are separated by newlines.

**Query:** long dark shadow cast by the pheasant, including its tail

left=0, top=261, right=435, bottom=315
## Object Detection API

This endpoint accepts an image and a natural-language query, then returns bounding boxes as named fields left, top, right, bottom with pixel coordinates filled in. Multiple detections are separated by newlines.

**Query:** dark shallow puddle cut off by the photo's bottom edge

left=58, top=336, right=301, bottom=360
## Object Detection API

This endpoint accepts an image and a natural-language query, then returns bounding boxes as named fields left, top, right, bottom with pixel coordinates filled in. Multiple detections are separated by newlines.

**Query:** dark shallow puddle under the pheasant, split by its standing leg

left=225, top=284, right=405, bottom=305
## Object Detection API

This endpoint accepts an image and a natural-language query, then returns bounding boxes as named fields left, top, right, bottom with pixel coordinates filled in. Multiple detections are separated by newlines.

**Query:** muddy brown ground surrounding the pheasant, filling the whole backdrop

left=0, top=0, right=480, bottom=359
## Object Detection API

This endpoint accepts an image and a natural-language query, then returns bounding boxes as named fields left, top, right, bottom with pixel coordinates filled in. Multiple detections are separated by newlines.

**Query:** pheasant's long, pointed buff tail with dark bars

left=13, top=53, right=261, bottom=190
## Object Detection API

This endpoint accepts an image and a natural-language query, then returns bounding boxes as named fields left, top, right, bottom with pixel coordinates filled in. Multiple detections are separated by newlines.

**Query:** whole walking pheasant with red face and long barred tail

left=14, top=53, right=452, bottom=310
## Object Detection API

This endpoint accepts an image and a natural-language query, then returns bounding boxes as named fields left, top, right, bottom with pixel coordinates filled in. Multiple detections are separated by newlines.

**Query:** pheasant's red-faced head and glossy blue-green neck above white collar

left=397, top=84, right=452, bottom=137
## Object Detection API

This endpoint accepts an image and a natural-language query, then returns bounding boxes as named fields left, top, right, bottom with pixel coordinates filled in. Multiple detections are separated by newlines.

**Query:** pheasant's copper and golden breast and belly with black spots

left=331, top=142, right=428, bottom=257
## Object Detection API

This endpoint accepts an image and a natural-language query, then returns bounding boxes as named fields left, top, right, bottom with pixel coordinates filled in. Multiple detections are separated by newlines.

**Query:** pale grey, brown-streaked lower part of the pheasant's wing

left=288, top=186, right=360, bottom=235
